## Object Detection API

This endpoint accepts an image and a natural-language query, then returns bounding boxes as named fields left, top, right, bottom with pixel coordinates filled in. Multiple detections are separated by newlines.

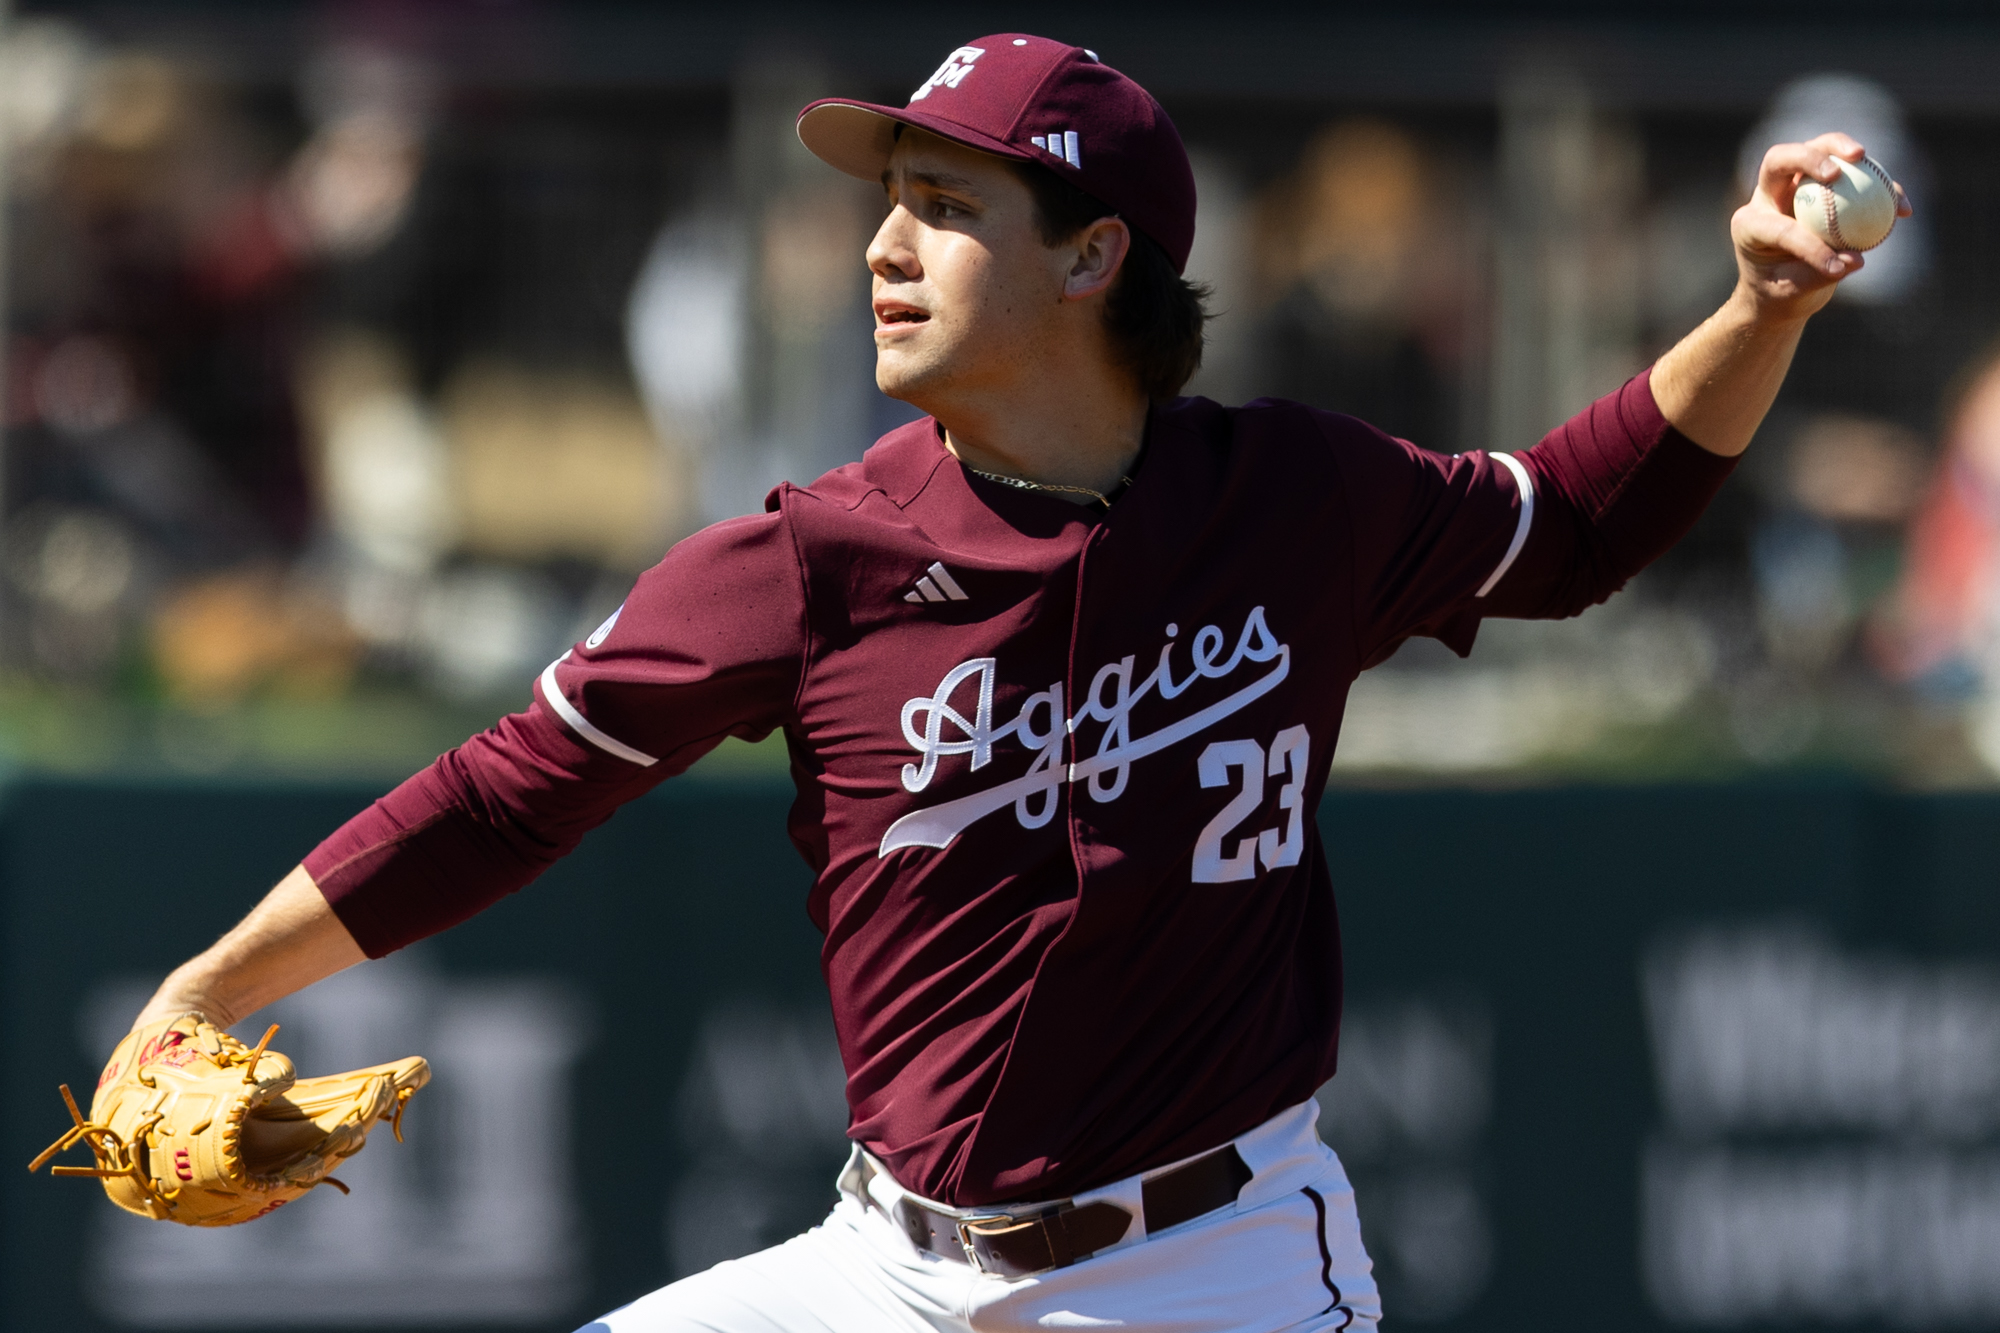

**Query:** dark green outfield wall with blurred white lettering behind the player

left=0, top=781, right=2000, bottom=1333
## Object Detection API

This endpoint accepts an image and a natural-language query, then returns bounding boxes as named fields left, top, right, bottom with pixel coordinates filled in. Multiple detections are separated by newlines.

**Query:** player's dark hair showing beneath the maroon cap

left=1010, top=162, right=1210, bottom=402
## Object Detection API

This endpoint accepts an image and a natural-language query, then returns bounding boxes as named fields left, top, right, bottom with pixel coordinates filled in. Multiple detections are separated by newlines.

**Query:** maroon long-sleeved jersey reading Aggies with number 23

left=306, top=376, right=1730, bottom=1205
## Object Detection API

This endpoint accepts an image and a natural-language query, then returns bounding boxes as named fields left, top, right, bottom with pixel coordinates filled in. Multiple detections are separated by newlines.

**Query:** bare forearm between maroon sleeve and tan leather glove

left=134, top=867, right=364, bottom=1027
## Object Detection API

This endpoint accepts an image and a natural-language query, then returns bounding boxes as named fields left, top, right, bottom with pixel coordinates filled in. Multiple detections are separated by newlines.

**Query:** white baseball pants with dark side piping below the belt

left=578, top=1101, right=1382, bottom=1333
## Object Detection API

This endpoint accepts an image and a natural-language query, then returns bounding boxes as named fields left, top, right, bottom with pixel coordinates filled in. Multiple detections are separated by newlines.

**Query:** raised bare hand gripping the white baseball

left=1730, top=134, right=1910, bottom=320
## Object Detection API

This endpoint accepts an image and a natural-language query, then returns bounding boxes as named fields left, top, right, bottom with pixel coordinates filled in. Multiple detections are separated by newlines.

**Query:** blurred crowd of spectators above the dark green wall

left=0, top=0, right=2000, bottom=785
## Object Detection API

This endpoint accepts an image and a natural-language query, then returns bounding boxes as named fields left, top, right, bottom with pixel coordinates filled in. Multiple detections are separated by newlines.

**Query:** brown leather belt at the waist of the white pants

left=862, top=1143, right=1252, bottom=1277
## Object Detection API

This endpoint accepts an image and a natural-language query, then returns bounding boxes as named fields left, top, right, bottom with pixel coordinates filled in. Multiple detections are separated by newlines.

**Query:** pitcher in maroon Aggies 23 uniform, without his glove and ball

left=66, top=32, right=1908, bottom=1333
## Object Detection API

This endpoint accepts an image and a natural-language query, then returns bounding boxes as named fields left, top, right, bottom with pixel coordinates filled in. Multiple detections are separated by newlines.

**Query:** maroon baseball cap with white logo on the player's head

left=798, top=32, right=1194, bottom=272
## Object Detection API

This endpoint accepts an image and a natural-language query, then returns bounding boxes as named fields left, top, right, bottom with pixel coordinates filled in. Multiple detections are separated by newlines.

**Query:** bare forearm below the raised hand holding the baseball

left=1652, top=288, right=1808, bottom=458
